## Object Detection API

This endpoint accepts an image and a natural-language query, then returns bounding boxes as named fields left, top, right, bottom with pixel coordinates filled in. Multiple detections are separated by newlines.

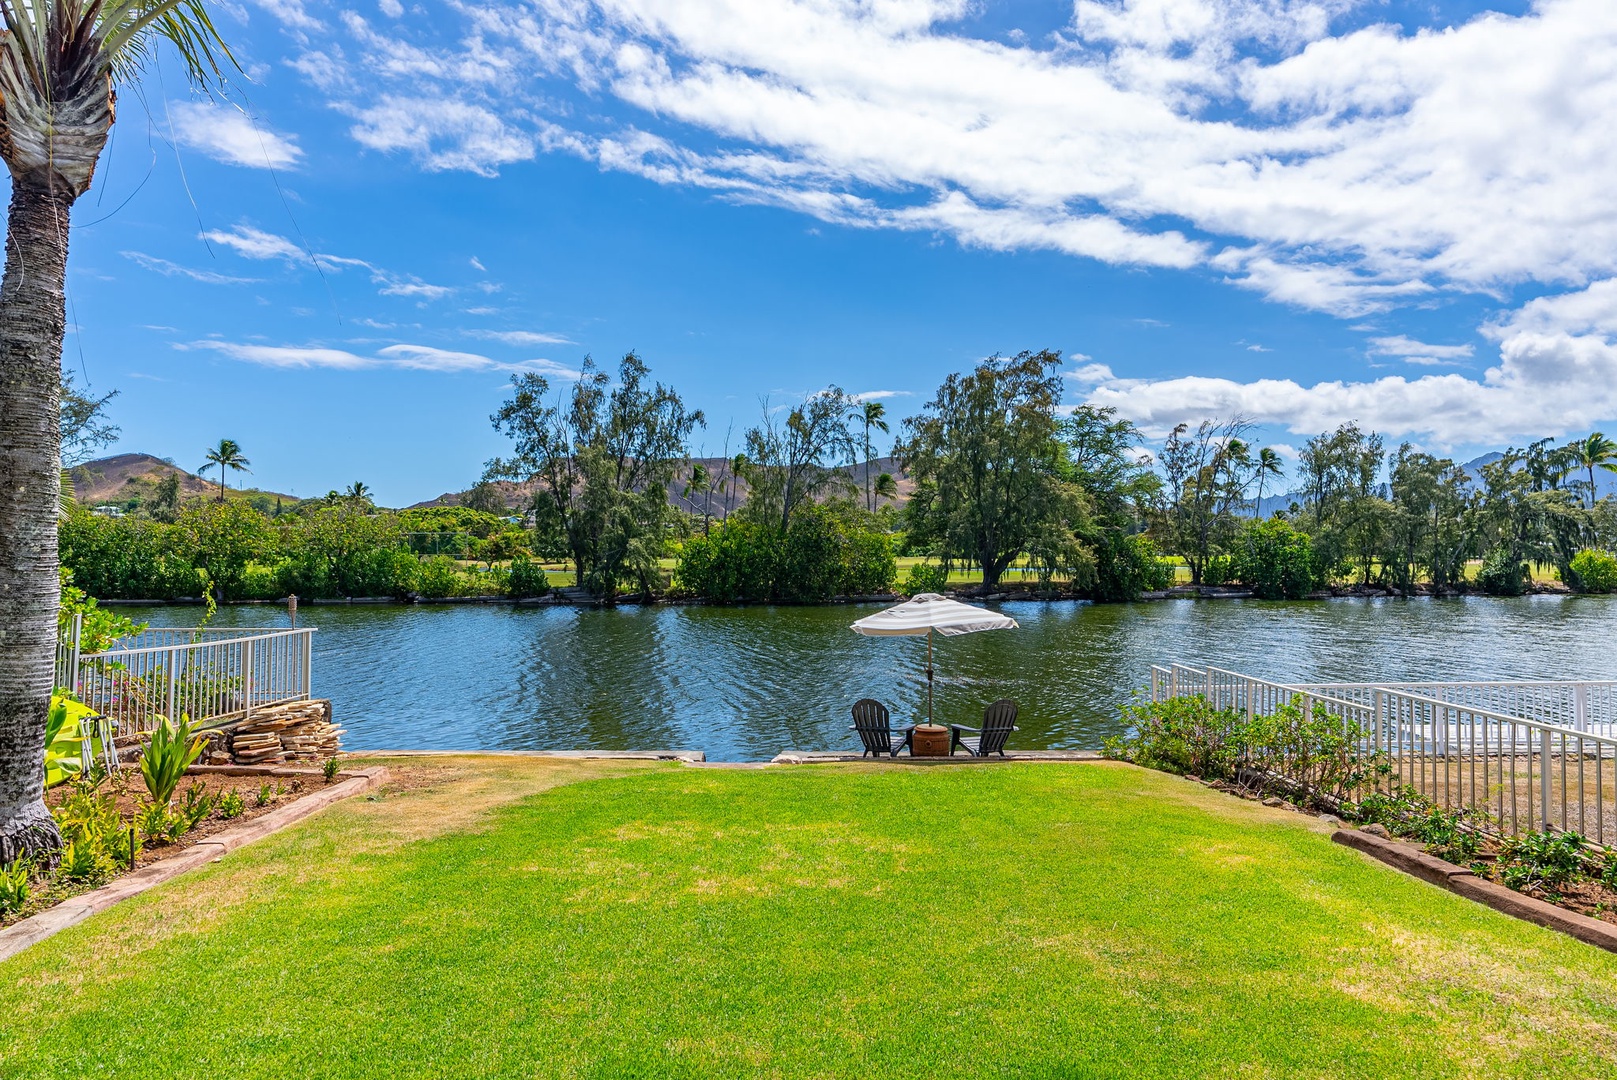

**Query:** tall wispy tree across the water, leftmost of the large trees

left=483, top=352, right=705, bottom=597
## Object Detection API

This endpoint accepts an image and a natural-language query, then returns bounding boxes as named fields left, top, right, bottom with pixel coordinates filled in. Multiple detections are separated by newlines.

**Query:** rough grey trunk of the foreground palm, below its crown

left=0, top=176, right=74, bottom=863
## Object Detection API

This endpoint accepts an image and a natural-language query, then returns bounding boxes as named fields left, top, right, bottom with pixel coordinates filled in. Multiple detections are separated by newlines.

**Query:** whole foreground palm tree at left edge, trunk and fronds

left=0, top=0, right=228, bottom=863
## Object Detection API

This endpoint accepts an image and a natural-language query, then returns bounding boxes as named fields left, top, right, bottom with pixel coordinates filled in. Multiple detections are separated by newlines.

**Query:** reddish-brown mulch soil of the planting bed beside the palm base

left=0, top=768, right=343, bottom=928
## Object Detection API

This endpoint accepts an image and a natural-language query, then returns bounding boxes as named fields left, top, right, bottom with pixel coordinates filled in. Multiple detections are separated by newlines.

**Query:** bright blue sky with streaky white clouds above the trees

left=63, top=0, right=1617, bottom=504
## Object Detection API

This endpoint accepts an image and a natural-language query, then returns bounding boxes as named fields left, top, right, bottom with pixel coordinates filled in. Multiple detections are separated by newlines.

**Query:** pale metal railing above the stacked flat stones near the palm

left=57, top=622, right=314, bottom=739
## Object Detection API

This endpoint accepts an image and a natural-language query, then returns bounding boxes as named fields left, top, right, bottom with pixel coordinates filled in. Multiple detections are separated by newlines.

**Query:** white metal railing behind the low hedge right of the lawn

left=1151, top=663, right=1617, bottom=846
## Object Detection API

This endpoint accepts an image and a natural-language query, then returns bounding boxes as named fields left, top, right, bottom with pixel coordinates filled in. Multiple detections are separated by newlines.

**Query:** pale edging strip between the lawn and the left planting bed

left=0, top=765, right=388, bottom=960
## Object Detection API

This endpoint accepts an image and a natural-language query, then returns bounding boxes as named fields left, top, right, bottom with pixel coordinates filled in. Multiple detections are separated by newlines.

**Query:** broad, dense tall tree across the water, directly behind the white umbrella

left=901, top=349, right=1093, bottom=589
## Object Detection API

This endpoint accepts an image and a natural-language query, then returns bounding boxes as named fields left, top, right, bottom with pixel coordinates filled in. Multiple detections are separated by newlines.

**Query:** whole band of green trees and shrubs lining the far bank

left=58, top=351, right=1617, bottom=605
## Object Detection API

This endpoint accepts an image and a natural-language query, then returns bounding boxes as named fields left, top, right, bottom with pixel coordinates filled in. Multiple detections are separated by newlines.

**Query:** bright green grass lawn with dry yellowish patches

left=0, top=758, right=1617, bottom=1080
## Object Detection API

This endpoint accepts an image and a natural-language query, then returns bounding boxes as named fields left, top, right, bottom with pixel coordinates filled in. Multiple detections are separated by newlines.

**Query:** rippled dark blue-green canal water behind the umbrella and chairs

left=123, top=597, right=1617, bottom=761
